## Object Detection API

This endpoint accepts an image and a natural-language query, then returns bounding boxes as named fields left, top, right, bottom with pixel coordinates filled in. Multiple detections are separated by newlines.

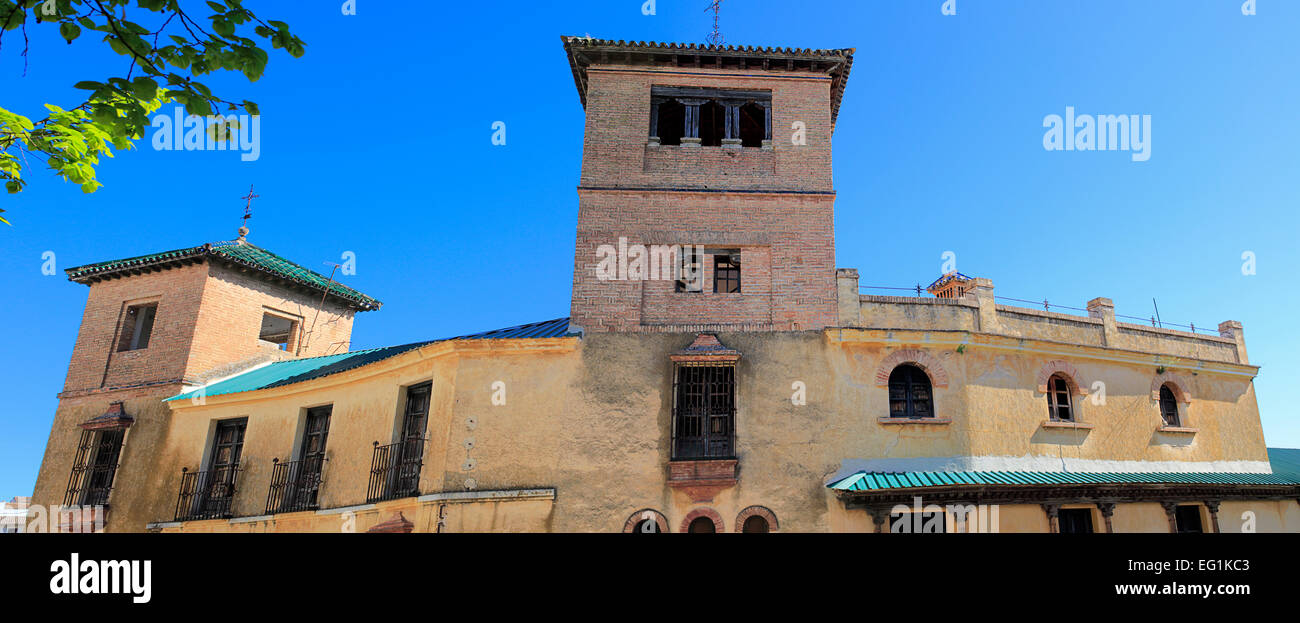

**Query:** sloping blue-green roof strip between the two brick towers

left=168, top=317, right=572, bottom=401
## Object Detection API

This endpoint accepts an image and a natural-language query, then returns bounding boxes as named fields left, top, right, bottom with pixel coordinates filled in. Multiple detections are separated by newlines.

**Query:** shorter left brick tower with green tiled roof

left=33, top=229, right=381, bottom=531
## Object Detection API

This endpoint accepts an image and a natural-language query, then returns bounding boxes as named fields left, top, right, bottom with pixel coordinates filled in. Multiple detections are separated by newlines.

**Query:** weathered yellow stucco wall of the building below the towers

left=114, top=330, right=1300, bottom=532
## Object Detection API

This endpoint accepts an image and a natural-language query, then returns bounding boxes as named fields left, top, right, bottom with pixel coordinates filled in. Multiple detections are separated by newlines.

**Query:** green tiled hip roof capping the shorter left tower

left=65, top=241, right=382, bottom=311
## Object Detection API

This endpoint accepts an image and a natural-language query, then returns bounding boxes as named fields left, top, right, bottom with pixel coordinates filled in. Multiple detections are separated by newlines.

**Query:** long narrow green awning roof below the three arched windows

left=827, top=470, right=1300, bottom=492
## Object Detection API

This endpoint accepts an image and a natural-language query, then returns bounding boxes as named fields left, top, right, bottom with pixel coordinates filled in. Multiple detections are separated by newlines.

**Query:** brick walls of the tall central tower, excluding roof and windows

left=571, top=65, right=836, bottom=332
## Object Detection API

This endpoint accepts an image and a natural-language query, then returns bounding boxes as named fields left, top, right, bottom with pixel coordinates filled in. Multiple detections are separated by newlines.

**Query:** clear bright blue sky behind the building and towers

left=0, top=0, right=1300, bottom=499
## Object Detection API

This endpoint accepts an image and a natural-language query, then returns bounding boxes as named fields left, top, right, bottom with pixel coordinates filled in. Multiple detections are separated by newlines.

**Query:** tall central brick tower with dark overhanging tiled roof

left=564, top=36, right=853, bottom=332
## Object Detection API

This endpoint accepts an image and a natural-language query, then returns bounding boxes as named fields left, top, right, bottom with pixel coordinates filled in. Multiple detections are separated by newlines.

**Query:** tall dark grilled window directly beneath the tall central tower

left=672, top=365, right=736, bottom=459
